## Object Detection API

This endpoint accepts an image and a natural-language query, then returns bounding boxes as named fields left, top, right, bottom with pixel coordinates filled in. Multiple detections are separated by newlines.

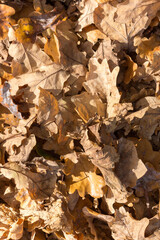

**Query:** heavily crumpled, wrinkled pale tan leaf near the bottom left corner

left=19, top=190, right=72, bottom=234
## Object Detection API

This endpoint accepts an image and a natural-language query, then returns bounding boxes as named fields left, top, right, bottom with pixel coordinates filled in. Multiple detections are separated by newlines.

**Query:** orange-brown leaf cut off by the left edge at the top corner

left=0, top=4, right=15, bottom=39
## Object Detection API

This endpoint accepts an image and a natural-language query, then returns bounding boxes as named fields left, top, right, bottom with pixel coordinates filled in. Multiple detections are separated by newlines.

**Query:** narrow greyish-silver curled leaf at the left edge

left=0, top=82, right=22, bottom=119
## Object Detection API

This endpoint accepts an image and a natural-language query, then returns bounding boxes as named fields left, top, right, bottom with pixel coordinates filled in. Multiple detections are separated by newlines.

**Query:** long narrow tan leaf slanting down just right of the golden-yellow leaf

left=80, top=130, right=130, bottom=203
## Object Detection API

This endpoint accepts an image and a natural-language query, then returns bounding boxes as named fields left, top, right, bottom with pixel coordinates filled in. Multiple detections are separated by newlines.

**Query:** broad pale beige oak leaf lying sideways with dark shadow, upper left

left=10, top=64, right=69, bottom=105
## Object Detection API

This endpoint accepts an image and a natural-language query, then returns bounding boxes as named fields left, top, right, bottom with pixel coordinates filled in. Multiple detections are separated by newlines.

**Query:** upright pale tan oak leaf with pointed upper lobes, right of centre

left=83, top=58, right=121, bottom=117
